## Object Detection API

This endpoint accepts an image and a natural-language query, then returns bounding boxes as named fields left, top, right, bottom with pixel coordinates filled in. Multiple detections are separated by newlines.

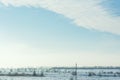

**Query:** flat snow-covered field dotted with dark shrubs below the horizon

left=0, top=68, right=120, bottom=80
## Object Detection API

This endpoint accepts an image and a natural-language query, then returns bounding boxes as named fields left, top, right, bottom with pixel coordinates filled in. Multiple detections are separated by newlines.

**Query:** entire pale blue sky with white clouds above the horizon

left=0, top=0, right=120, bottom=68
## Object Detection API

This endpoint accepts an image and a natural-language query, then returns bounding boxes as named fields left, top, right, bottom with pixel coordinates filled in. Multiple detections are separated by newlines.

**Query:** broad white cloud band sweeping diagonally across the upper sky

left=0, top=0, right=120, bottom=34
